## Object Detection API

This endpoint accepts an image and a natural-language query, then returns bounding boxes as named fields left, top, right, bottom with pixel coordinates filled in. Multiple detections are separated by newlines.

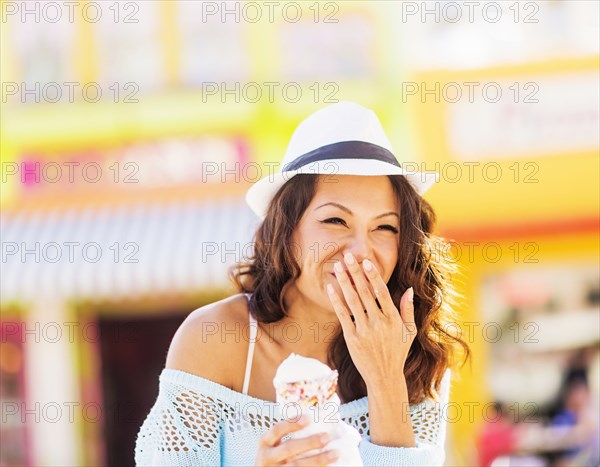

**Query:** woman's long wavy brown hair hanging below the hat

left=229, top=174, right=470, bottom=404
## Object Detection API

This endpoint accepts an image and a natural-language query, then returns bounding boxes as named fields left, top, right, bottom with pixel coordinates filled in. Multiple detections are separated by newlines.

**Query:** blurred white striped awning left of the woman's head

left=0, top=199, right=260, bottom=303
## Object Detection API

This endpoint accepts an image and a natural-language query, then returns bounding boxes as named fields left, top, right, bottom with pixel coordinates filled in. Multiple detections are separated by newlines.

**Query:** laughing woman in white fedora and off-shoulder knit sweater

left=136, top=102, right=469, bottom=466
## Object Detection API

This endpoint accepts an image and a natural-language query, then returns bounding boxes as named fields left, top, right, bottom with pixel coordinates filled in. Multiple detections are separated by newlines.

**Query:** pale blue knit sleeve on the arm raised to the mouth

left=359, top=370, right=450, bottom=467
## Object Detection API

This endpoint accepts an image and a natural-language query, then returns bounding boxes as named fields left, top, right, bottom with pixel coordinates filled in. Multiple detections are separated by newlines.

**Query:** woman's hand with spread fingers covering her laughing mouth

left=327, top=253, right=417, bottom=387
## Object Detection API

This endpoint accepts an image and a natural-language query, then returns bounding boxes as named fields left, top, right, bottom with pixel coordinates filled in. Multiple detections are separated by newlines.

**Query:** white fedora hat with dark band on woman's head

left=246, top=101, right=439, bottom=219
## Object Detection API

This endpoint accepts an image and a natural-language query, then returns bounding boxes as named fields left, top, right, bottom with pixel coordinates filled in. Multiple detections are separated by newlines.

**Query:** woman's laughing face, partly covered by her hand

left=292, top=175, right=400, bottom=308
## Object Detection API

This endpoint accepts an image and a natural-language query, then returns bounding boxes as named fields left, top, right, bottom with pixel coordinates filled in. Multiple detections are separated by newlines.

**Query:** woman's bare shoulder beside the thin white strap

left=165, top=294, right=248, bottom=388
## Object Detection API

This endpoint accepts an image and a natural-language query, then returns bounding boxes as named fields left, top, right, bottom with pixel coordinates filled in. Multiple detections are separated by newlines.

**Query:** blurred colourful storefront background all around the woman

left=0, top=0, right=600, bottom=466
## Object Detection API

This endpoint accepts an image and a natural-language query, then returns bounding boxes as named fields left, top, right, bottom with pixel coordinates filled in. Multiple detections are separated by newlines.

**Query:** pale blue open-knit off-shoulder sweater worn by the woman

left=135, top=368, right=450, bottom=466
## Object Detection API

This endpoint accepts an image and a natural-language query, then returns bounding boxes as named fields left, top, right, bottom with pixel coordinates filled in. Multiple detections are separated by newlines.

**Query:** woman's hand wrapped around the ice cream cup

left=254, top=417, right=339, bottom=466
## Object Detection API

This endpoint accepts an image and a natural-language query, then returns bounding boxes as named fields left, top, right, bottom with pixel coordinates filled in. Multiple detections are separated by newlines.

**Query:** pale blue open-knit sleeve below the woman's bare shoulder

left=135, top=375, right=223, bottom=466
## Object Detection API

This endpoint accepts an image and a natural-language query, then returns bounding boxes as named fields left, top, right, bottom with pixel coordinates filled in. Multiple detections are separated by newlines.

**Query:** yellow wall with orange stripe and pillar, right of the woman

left=411, top=57, right=600, bottom=464
